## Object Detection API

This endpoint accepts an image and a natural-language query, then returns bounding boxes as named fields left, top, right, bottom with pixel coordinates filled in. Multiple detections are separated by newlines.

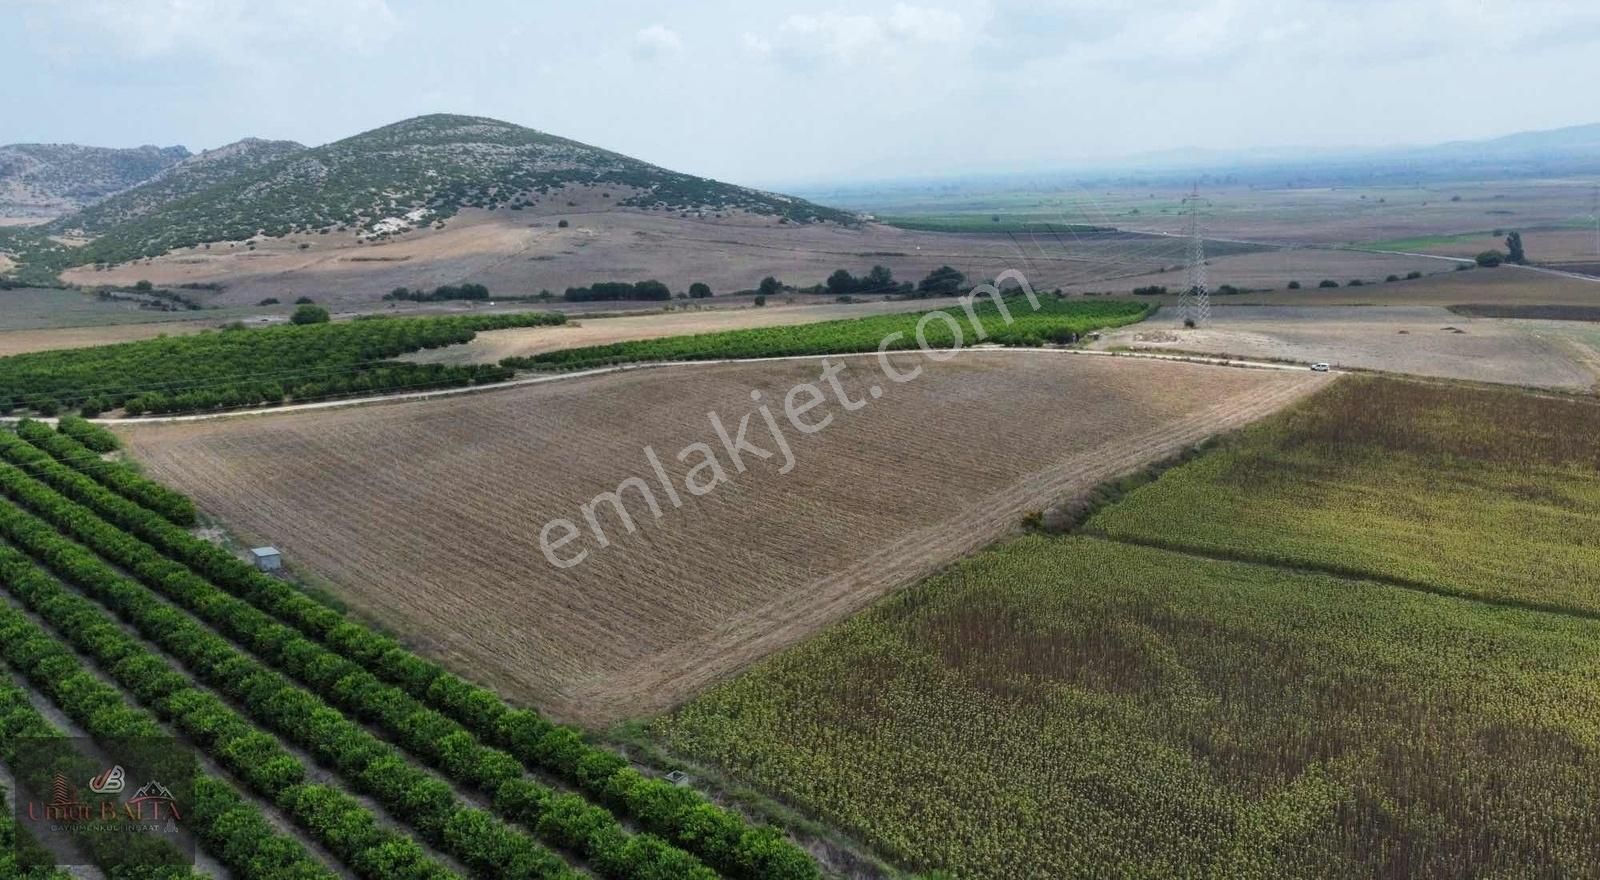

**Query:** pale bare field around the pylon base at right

left=1098, top=306, right=1600, bottom=390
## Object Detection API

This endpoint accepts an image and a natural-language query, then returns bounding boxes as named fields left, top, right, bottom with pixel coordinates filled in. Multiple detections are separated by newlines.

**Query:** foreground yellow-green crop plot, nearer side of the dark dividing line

left=654, top=536, right=1600, bottom=878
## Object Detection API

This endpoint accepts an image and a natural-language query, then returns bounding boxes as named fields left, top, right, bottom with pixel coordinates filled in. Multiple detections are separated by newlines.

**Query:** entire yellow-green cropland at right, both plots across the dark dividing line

left=650, top=378, right=1600, bottom=878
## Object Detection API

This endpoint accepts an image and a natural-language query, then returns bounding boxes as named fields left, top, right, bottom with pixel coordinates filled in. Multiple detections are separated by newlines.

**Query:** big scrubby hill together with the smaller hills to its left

left=0, top=115, right=854, bottom=280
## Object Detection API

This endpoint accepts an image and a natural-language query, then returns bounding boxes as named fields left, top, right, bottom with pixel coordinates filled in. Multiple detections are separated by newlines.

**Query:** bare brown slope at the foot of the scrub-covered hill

left=62, top=200, right=1182, bottom=307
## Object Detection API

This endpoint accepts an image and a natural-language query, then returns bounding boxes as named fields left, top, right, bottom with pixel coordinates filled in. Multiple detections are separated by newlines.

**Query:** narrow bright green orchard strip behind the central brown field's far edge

left=501, top=296, right=1150, bottom=370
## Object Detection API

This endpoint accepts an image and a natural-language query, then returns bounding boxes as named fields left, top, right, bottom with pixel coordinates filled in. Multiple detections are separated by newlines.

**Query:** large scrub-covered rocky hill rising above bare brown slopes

left=56, top=115, right=854, bottom=264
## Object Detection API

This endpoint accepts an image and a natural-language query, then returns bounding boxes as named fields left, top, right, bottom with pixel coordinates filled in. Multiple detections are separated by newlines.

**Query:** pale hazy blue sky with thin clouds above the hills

left=12, top=0, right=1600, bottom=186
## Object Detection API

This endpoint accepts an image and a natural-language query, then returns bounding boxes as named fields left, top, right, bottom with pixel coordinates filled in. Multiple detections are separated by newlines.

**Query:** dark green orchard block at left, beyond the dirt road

left=0, top=312, right=566, bottom=416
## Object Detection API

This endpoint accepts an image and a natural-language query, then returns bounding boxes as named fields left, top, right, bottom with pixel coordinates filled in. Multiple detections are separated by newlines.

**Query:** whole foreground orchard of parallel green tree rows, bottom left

left=0, top=421, right=821, bottom=880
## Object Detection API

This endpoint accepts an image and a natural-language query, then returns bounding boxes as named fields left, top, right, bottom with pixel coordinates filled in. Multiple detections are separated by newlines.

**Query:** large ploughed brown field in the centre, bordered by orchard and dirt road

left=122, top=352, right=1330, bottom=725
